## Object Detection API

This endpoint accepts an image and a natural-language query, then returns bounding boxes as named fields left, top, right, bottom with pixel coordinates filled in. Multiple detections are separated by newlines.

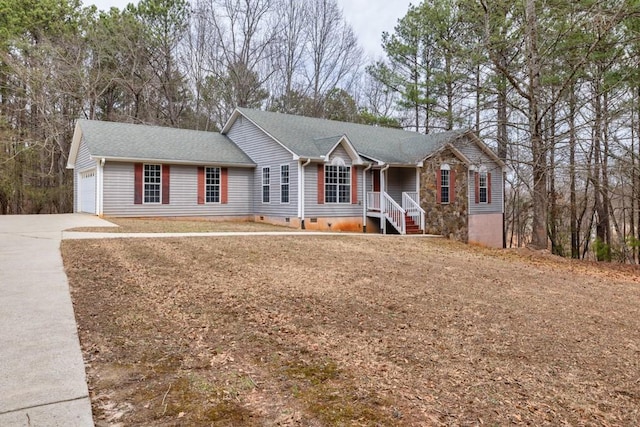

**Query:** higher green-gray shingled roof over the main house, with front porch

left=222, top=108, right=465, bottom=164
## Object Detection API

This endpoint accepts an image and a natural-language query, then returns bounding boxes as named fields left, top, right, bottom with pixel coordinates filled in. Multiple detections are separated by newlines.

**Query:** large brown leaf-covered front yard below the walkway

left=62, top=235, right=640, bottom=426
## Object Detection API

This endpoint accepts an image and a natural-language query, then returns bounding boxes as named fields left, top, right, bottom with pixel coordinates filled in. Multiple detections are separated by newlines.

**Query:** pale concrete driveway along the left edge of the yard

left=0, top=214, right=111, bottom=427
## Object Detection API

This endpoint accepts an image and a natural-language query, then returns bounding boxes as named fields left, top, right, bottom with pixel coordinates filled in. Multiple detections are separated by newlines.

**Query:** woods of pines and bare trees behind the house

left=0, top=0, right=640, bottom=263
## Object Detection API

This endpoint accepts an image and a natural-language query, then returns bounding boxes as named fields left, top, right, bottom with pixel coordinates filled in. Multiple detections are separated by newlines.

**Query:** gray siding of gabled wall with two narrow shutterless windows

left=227, top=116, right=298, bottom=217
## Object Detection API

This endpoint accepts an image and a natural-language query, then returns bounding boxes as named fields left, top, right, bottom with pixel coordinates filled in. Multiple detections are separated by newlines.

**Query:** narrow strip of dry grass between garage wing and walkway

left=69, top=217, right=298, bottom=233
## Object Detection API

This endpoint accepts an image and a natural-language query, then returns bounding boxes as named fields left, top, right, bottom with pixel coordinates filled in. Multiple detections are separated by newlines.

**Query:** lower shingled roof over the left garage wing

left=69, top=120, right=255, bottom=167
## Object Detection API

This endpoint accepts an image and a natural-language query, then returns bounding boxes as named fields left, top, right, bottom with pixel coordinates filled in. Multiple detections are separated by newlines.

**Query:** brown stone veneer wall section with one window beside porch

left=420, top=150, right=469, bottom=243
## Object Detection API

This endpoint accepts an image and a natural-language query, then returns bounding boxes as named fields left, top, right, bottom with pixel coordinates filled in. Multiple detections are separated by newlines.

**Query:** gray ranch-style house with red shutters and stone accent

left=67, top=108, right=505, bottom=247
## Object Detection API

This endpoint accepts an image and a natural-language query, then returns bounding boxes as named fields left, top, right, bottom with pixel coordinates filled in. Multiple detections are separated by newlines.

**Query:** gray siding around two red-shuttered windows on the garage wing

left=103, top=162, right=253, bottom=216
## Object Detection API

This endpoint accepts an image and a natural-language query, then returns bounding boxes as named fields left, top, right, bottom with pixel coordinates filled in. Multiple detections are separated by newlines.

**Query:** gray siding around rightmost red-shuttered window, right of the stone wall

left=455, top=139, right=504, bottom=215
